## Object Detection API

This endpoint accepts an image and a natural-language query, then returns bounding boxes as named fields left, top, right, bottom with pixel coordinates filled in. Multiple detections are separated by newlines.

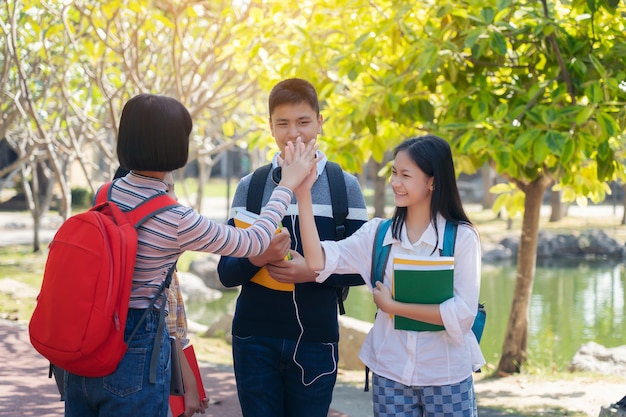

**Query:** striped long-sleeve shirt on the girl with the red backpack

left=109, top=172, right=292, bottom=308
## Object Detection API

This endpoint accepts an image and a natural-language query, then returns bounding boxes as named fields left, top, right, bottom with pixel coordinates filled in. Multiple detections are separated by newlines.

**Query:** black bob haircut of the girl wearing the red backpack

left=117, top=94, right=193, bottom=172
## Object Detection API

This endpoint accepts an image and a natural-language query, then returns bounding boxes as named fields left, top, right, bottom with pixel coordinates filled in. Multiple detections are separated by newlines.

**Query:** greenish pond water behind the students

left=188, top=260, right=626, bottom=370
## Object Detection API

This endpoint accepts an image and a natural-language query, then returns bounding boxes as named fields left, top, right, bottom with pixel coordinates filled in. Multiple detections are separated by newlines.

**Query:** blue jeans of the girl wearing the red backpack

left=65, top=309, right=171, bottom=417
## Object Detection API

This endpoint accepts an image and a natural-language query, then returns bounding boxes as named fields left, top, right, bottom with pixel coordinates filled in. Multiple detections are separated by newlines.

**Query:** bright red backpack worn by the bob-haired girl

left=29, top=182, right=179, bottom=377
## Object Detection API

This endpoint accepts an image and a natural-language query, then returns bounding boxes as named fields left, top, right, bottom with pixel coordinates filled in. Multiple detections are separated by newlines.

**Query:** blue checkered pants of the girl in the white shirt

left=372, top=374, right=478, bottom=417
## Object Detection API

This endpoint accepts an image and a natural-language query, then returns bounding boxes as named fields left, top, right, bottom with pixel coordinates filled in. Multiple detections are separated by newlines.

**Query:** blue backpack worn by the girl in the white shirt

left=371, top=219, right=487, bottom=343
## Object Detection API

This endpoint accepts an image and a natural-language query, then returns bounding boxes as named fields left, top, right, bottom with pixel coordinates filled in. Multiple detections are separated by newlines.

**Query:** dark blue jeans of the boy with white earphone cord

left=233, top=336, right=338, bottom=417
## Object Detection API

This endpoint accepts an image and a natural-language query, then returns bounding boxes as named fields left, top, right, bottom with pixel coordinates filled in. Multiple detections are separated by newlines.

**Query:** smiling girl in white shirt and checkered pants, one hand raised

left=295, top=135, right=485, bottom=417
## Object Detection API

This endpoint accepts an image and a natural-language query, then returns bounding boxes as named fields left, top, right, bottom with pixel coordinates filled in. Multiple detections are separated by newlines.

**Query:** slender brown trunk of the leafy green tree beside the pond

left=498, top=177, right=550, bottom=376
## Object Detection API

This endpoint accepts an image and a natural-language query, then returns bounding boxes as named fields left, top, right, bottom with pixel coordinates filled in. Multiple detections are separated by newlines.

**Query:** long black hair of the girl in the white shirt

left=391, top=135, right=471, bottom=239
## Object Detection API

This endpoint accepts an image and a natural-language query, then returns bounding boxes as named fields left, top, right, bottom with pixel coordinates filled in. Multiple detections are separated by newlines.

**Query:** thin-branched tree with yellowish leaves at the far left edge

left=1, top=2, right=100, bottom=251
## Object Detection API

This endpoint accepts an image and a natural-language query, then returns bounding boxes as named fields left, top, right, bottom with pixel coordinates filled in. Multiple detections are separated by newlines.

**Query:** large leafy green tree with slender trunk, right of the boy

left=280, top=0, right=626, bottom=374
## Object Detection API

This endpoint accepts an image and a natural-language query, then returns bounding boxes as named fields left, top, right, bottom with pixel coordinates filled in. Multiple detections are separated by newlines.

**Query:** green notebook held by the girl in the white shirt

left=392, top=255, right=454, bottom=331
